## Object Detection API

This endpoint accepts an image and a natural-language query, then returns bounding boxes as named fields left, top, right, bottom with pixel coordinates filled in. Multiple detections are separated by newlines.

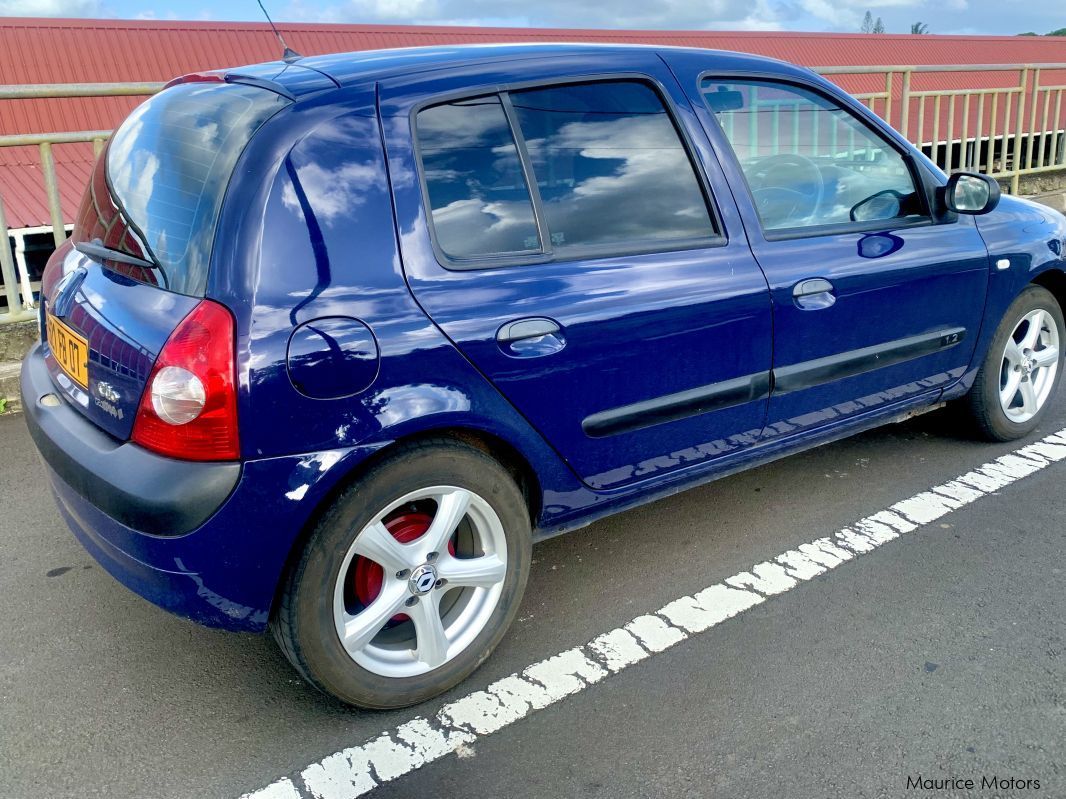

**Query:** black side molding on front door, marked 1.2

left=774, top=327, right=966, bottom=394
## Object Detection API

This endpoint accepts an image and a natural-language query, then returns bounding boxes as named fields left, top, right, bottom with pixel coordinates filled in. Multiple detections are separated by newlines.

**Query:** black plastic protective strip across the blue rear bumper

left=21, top=342, right=241, bottom=536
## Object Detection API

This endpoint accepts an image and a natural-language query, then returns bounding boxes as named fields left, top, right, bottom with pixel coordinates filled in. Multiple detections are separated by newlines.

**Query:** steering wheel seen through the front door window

left=747, top=152, right=825, bottom=228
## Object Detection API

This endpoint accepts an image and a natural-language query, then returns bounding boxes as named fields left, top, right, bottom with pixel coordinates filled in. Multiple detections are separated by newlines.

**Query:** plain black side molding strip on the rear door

left=581, top=372, right=770, bottom=438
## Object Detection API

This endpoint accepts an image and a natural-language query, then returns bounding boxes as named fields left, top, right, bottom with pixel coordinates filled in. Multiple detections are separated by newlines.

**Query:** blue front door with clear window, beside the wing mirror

left=675, top=58, right=988, bottom=437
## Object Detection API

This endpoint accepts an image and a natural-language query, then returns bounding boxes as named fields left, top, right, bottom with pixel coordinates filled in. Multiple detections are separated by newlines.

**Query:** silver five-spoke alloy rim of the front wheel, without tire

left=1000, top=308, right=1060, bottom=424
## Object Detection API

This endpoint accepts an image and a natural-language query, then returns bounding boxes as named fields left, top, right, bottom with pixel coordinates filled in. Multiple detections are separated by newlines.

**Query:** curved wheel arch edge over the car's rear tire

left=270, top=426, right=544, bottom=618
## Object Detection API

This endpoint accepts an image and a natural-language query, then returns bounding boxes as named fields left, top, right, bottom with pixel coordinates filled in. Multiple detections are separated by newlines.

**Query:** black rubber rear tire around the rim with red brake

left=271, top=439, right=532, bottom=710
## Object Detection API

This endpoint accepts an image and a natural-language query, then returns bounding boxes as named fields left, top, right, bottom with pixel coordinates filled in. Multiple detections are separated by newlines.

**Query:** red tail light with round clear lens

left=131, top=299, right=241, bottom=460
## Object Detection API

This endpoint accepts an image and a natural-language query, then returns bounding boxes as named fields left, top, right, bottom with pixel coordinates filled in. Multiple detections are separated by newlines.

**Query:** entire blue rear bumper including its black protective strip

left=22, top=345, right=372, bottom=632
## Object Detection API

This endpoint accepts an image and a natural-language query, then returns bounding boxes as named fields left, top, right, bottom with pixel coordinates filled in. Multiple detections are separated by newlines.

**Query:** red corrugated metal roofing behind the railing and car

left=0, top=18, right=1066, bottom=228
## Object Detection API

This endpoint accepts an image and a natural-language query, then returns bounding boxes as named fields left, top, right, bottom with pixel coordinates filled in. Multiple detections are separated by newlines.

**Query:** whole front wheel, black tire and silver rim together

left=965, top=286, right=1066, bottom=441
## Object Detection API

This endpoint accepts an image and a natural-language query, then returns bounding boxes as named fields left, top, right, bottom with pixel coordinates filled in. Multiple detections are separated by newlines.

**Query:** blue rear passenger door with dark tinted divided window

left=381, top=53, right=771, bottom=489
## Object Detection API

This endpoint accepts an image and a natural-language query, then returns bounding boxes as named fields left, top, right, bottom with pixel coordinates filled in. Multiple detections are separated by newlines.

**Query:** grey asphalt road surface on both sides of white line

left=0, top=406, right=1066, bottom=799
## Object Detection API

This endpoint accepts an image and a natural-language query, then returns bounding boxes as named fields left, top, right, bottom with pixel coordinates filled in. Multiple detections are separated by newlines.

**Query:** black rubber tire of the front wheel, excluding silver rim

left=962, top=286, right=1066, bottom=441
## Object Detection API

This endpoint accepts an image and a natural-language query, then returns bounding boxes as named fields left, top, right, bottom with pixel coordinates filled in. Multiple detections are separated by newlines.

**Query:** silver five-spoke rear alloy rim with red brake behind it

left=333, top=486, right=507, bottom=678
